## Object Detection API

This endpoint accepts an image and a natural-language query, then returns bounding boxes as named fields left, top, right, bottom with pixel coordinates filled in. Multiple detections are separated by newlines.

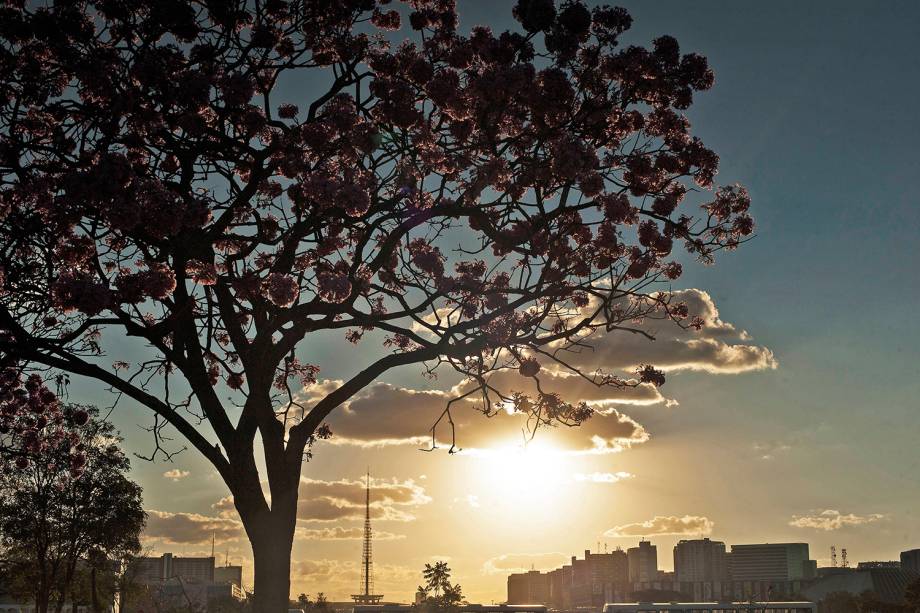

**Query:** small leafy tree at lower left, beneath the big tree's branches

left=0, top=408, right=146, bottom=613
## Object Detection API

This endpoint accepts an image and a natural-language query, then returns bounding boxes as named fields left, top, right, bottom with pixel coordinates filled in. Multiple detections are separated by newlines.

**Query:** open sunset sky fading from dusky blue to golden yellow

left=75, top=0, right=920, bottom=601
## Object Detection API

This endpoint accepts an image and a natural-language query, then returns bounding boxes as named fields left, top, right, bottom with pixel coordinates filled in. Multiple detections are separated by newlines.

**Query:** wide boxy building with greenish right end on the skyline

left=728, top=543, right=815, bottom=581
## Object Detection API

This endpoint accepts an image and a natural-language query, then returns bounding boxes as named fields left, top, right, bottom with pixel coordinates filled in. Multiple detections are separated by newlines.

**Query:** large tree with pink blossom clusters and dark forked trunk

left=0, top=0, right=753, bottom=613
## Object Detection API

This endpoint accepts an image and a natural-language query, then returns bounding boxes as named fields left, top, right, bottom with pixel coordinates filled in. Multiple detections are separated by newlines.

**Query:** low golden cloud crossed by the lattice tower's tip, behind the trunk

left=212, top=477, right=431, bottom=522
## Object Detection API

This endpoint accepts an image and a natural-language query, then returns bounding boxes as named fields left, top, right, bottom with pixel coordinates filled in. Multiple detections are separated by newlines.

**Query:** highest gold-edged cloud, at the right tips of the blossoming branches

left=564, top=289, right=778, bottom=374
